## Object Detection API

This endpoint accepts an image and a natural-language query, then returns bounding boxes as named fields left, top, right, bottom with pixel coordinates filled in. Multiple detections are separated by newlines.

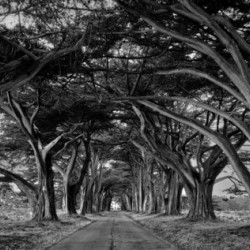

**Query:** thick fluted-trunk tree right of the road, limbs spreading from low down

left=134, top=101, right=248, bottom=218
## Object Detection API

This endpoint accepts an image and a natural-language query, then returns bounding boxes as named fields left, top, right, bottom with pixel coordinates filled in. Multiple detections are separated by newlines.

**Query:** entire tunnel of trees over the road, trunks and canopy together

left=0, top=0, right=250, bottom=220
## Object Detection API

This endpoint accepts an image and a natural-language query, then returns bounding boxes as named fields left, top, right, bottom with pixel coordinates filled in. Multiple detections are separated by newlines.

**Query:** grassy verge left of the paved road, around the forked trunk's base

left=0, top=209, right=91, bottom=250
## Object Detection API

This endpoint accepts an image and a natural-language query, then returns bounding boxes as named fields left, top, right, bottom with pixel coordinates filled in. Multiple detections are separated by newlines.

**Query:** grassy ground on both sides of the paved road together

left=0, top=209, right=250, bottom=250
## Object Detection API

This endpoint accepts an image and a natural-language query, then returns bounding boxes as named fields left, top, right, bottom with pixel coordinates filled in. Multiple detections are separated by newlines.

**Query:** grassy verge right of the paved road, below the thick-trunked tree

left=129, top=213, right=250, bottom=250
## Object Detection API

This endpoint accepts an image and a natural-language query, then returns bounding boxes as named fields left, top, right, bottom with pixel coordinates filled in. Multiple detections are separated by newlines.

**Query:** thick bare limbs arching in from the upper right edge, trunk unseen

left=114, top=0, right=249, bottom=217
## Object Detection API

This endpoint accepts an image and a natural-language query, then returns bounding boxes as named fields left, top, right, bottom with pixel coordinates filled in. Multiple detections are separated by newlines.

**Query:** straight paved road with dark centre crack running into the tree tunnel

left=49, top=212, right=177, bottom=250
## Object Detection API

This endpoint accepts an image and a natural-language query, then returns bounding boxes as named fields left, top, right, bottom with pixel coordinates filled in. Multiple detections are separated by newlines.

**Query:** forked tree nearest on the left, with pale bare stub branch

left=1, top=93, right=82, bottom=220
